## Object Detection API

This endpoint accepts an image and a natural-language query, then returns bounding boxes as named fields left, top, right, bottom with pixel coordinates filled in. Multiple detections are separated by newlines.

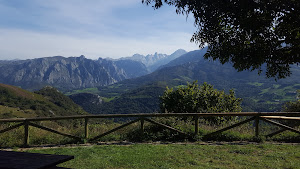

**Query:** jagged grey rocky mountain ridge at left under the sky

left=0, top=56, right=148, bottom=90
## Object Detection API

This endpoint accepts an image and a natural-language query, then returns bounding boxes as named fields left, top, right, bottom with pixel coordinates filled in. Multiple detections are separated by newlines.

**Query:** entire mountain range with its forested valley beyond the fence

left=0, top=48, right=300, bottom=114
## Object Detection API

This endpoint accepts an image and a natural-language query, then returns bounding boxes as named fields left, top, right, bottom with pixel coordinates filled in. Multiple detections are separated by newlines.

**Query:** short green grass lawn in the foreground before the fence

left=28, top=143, right=300, bottom=169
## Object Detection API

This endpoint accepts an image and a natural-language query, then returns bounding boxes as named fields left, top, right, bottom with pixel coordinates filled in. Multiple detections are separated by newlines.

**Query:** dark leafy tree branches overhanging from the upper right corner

left=142, top=0, right=300, bottom=79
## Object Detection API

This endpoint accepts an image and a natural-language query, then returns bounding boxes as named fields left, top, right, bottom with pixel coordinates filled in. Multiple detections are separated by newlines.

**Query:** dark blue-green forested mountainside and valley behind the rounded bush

left=67, top=50, right=300, bottom=114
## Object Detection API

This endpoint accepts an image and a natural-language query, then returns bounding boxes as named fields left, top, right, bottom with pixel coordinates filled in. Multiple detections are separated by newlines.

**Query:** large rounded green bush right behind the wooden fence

left=160, top=81, right=242, bottom=122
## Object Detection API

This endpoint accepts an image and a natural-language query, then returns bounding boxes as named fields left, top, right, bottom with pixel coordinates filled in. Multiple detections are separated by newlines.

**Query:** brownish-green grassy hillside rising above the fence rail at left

left=0, top=84, right=86, bottom=118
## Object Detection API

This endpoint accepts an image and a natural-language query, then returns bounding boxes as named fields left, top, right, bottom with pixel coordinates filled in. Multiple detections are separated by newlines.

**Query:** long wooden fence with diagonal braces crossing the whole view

left=0, top=112, right=300, bottom=147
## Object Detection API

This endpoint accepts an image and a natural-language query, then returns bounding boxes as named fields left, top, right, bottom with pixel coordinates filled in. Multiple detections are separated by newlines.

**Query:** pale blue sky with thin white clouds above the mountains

left=0, top=0, right=198, bottom=60
